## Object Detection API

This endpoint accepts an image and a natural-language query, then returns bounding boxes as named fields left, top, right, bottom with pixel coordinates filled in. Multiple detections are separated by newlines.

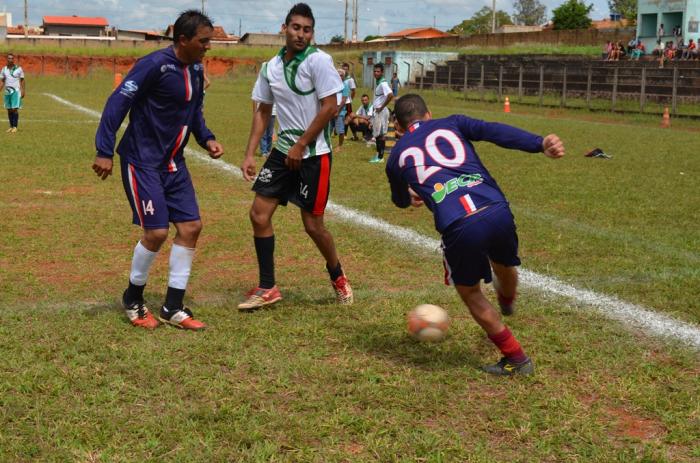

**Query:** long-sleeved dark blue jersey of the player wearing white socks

left=95, top=47, right=214, bottom=172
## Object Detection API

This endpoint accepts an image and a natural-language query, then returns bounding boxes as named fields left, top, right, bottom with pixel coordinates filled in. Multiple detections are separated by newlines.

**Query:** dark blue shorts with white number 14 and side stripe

left=121, top=158, right=199, bottom=228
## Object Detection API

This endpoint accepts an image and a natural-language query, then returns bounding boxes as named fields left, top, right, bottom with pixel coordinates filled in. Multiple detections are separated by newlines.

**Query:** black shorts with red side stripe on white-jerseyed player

left=253, top=148, right=332, bottom=215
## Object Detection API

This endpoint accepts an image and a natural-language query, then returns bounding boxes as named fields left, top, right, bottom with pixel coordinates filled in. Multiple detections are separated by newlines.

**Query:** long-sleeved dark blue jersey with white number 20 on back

left=386, top=115, right=542, bottom=233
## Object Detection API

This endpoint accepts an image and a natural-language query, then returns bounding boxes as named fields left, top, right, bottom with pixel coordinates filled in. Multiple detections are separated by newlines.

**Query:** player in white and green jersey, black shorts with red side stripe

left=238, top=3, right=353, bottom=311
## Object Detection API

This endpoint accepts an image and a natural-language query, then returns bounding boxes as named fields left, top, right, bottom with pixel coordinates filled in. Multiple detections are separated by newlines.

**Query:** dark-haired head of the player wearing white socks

left=173, top=10, right=214, bottom=64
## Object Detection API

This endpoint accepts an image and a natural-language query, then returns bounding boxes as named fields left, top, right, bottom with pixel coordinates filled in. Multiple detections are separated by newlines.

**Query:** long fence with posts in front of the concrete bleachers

left=414, top=61, right=700, bottom=117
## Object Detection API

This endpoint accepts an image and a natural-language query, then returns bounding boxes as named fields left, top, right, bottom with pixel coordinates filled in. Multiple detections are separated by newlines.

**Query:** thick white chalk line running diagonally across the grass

left=45, top=93, right=700, bottom=350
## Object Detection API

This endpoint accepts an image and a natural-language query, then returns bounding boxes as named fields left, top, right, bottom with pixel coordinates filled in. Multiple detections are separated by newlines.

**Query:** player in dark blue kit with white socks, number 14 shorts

left=92, top=10, right=223, bottom=330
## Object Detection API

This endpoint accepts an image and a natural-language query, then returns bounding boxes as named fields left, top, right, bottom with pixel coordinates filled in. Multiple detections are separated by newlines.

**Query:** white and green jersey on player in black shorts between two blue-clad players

left=253, top=46, right=343, bottom=159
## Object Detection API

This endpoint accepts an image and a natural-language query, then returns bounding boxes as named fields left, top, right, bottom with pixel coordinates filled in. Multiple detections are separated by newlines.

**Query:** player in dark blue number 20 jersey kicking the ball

left=386, top=94, right=564, bottom=375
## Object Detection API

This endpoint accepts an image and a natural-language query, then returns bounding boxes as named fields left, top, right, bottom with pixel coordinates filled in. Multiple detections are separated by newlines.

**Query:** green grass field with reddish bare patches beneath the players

left=0, top=77, right=700, bottom=462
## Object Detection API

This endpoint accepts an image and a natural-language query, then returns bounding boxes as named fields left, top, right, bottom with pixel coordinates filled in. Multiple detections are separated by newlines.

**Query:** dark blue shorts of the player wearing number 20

left=442, top=204, right=520, bottom=286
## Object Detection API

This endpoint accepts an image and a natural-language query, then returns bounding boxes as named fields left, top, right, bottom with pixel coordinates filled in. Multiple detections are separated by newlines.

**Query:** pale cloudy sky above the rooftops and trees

left=0, top=0, right=609, bottom=43
